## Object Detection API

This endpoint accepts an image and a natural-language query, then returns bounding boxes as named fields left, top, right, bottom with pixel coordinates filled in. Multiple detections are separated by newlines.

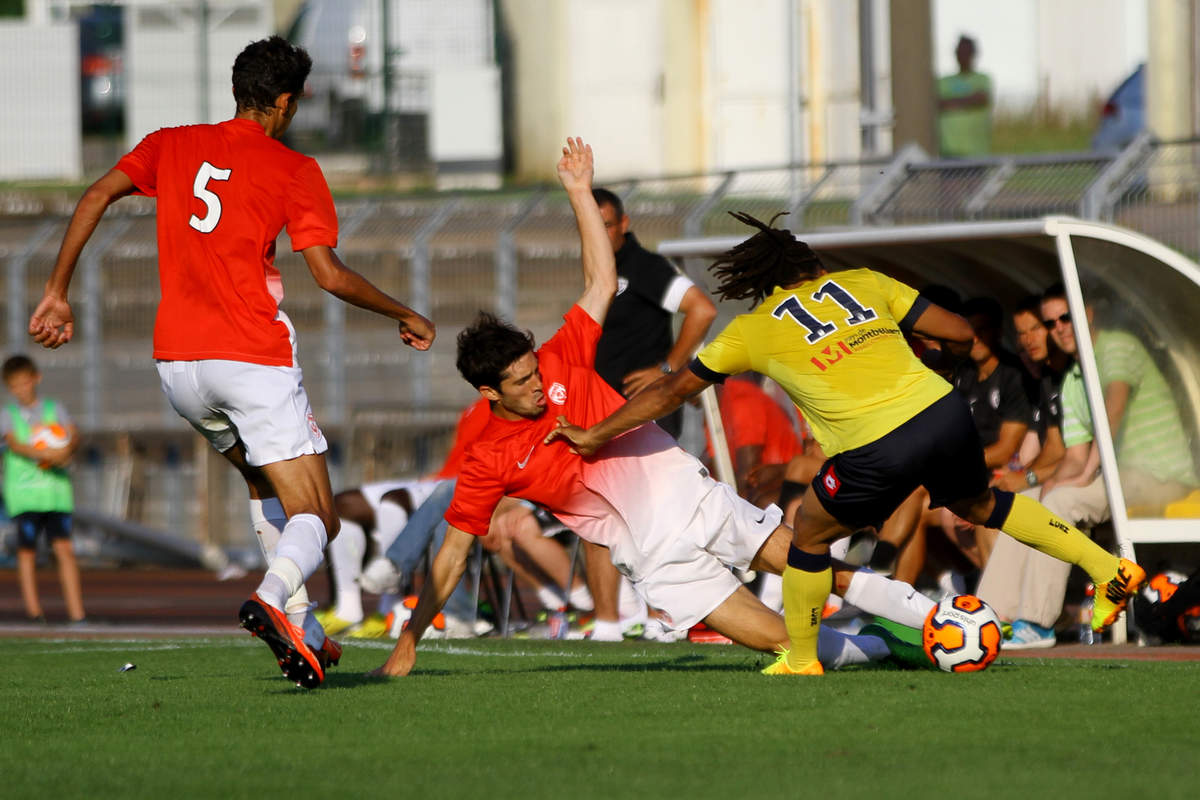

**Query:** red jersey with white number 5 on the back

left=116, top=119, right=337, bottom=367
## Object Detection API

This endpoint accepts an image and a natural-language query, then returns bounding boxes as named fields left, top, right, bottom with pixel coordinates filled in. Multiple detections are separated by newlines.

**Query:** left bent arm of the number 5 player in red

left=29, top=169, right=134, bottom=349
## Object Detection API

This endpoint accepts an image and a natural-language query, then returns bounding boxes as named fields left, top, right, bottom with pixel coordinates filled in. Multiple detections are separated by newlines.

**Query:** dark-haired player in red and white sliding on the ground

left=376, top=139, right=932, bottom=675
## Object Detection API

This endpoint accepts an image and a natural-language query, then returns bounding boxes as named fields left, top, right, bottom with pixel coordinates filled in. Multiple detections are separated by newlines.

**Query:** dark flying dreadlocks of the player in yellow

left=708, top=211, right=823, bottom=305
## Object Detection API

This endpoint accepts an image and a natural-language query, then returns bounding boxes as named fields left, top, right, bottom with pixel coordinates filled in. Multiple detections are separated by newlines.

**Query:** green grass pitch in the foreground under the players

left=0, top=636, right=1200, bottom=800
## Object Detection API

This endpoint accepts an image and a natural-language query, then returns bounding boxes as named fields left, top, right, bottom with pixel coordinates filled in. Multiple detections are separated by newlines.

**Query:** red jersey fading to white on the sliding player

left=445, top=306, right=700, bottom=545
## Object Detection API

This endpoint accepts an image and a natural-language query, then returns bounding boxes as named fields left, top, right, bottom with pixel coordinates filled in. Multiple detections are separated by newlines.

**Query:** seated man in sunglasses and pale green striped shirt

left=979, top=287, right=1198, bottom=649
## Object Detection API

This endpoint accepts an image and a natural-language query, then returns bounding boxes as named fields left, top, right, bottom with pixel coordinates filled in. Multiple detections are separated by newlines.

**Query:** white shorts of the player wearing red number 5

left=157, top=359, right=329, bottom=467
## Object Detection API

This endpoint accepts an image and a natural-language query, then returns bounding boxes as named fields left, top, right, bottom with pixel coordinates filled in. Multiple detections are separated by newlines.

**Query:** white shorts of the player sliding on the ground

left=612, top=479, right=784, bottom=630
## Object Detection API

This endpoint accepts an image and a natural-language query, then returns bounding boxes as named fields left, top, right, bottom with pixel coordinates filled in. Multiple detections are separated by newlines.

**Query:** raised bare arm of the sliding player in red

left=558, top=138, right=617, bottom=324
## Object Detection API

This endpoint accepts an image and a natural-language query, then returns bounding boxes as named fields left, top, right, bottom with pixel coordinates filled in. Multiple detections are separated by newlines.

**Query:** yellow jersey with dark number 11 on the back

left=697, top=269, right=952, bottom=456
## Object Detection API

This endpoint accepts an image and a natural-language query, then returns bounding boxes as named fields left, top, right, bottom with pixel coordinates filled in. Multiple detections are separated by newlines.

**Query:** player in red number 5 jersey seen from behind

left=29, top=36, right=434, bottom=688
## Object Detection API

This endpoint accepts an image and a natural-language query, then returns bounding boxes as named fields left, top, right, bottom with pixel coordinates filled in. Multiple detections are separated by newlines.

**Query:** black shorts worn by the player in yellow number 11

left=812, top=391, right=991, bottom=529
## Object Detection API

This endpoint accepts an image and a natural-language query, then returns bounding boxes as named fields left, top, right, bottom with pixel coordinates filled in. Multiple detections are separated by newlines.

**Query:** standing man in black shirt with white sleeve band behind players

left=592, top=188, right=716, bottom=438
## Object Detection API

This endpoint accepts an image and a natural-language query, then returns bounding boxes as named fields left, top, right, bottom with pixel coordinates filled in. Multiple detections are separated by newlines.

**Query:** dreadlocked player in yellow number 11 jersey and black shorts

left=547, top=215, right=1145, bottom=675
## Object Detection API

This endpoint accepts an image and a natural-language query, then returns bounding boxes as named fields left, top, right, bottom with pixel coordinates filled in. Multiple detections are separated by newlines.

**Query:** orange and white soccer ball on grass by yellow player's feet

left=922, top=595, right=1002, bottom=672
